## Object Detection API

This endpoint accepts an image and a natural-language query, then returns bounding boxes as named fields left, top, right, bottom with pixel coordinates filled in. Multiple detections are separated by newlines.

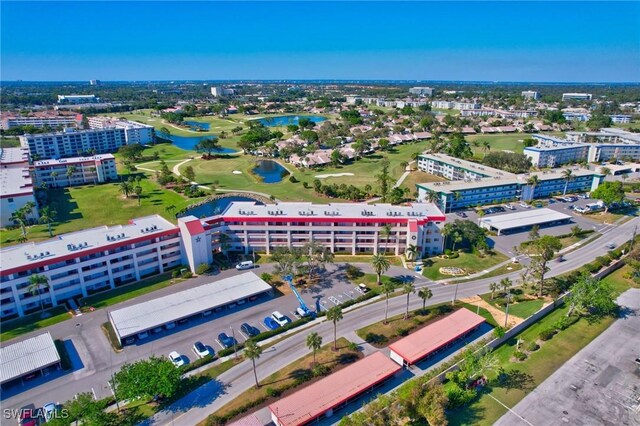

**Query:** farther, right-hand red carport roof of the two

left=389, top=308, right=485, bottom=364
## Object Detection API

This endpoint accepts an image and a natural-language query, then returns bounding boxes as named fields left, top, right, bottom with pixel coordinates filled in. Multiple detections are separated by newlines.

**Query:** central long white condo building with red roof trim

left=203, top=202, right=445, bottom=255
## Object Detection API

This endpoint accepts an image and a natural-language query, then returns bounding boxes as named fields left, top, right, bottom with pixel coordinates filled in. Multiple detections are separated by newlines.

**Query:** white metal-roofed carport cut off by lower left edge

left=0, top=332, right=60, bottom=384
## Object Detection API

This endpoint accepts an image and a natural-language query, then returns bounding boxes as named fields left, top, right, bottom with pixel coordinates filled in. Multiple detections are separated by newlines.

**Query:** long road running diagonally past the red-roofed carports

left=145, top=218, right=640, bottom=425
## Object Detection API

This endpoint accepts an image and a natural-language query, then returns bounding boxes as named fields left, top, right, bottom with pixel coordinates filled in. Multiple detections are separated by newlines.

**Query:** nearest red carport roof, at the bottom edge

left=269, top=352, right=402, bottom=426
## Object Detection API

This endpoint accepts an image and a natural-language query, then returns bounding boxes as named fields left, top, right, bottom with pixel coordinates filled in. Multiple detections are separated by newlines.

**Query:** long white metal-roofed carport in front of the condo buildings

left=109, top=272, right=273, bottom=344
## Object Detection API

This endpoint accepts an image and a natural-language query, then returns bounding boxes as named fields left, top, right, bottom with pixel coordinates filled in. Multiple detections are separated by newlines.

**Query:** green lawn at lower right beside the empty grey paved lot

left=447, top=307, right=615, bottom=425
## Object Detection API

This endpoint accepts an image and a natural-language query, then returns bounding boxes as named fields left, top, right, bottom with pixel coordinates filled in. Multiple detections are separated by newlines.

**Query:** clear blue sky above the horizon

left=0, top=1, right=640, bottom=82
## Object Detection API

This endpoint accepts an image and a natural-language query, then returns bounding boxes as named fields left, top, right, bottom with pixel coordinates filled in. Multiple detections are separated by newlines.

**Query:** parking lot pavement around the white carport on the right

left=446, top=197, right=610, bottom=256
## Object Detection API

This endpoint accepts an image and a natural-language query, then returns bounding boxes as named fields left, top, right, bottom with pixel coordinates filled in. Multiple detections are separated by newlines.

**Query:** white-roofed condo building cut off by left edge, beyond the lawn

left=0, top=148, right=38, bottom=227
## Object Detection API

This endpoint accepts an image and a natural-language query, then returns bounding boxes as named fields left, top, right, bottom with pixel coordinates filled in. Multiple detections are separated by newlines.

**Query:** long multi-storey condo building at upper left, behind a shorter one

left=20, top=129, right=127, bottom=159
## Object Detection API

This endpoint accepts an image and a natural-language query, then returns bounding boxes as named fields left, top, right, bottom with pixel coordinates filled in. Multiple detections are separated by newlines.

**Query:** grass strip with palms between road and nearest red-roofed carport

left=199, top=337, right=362, bottom=425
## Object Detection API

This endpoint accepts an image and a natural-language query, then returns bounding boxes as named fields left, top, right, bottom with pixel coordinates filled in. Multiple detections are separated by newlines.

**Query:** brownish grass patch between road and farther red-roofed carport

left=356, top=303, right=454, bottom=348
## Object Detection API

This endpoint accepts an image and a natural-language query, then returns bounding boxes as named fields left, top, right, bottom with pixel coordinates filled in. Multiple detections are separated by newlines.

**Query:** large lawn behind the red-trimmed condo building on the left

left=0, top=179, right=198, bottom=245
